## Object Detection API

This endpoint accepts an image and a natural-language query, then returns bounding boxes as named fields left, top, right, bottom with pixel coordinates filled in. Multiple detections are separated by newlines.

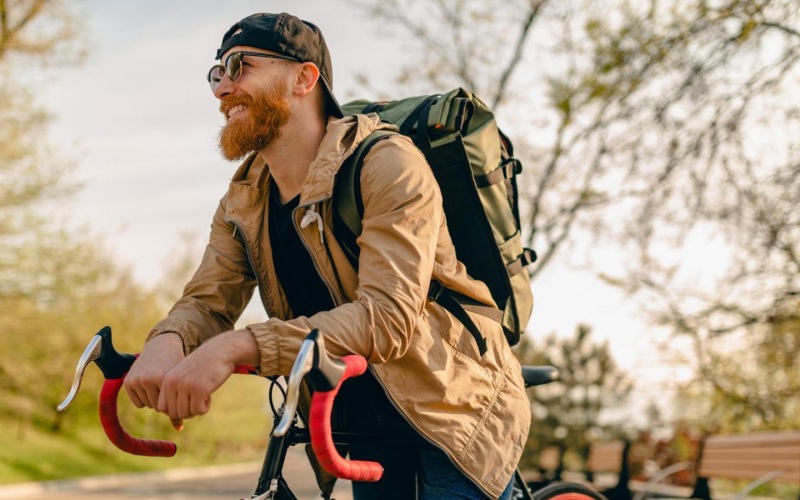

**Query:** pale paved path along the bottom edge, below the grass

left=0, top=448, right=352, bottom=500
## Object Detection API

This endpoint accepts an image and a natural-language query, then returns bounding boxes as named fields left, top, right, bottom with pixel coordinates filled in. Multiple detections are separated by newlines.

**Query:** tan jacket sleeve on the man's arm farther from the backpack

left=148, top=198, right=255, bottom=354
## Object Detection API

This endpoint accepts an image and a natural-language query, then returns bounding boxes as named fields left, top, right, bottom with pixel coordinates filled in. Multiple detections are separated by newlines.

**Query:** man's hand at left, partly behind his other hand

left=125, top=333, right=184, bottom=428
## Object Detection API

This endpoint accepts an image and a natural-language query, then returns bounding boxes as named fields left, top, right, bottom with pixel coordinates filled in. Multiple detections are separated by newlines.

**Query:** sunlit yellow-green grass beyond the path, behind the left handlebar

left=0, top=376, right=272, bottom=484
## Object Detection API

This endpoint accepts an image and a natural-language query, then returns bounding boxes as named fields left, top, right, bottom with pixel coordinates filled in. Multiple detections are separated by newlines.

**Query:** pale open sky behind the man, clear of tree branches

left=42, top=0, right=688, bottom=422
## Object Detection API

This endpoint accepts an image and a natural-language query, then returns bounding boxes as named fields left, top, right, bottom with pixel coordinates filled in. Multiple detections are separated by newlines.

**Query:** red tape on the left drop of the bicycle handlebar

left=100, top=375, right=178, bottom=457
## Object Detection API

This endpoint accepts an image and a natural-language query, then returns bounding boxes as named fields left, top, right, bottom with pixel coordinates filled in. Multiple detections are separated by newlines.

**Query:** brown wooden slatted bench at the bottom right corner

left=635, top=431, right=800, bottom=500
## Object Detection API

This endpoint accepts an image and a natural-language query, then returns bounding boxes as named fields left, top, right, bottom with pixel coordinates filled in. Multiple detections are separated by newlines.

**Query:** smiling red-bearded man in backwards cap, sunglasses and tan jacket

left=125, top=14, right=530, bottom=499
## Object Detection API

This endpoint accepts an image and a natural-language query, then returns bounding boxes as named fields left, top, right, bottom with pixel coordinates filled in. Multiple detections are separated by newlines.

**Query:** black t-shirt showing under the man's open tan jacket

left=269, top=184, right=333, bottom=317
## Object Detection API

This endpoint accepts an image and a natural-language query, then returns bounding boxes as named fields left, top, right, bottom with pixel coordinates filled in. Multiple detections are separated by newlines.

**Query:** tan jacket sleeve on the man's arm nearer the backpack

left=248, top=136, right=444, bottom=375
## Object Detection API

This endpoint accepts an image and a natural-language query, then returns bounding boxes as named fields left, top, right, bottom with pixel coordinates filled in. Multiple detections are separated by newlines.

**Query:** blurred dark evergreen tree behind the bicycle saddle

left=518, top=325, right=633, bottom=470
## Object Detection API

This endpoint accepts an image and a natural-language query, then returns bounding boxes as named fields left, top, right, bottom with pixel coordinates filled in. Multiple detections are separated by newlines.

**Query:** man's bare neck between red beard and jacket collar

left=260, top=114, right=326, bottom=203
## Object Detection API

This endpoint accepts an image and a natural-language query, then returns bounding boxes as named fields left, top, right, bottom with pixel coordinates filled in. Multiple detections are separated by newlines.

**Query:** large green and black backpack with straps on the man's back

left=334, top=89, right=536, bottom=354
